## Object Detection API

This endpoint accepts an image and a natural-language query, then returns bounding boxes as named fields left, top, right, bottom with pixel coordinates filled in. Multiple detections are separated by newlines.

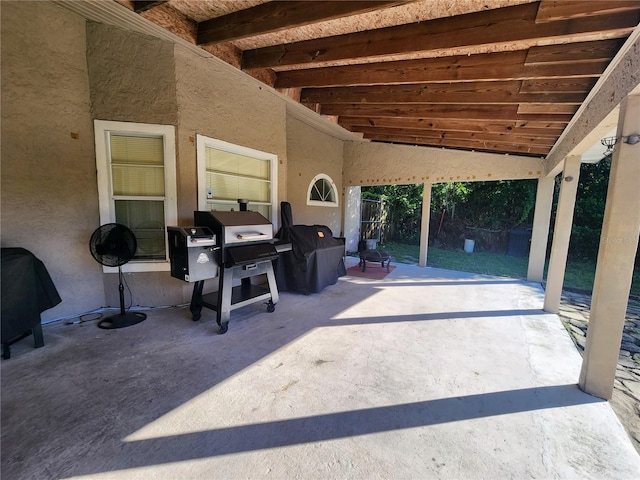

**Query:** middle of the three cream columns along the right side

left=543, top=156, right=580, bottom=313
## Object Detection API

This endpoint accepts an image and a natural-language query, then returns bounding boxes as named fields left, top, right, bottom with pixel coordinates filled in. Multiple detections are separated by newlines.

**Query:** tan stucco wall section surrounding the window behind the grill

left=175, top=47, right=287, bottom=225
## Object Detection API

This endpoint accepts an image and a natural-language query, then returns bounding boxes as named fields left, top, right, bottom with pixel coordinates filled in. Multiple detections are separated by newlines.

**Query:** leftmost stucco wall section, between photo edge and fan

left=1, top=2, right=104, bottom=322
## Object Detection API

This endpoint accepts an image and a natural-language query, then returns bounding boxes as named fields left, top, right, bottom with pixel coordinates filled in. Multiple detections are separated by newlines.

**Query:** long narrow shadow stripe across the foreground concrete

left=117, top=385, right=605, bottom=467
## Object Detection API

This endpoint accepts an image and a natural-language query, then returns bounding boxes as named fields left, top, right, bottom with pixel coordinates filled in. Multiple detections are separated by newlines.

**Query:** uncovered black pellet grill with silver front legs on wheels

left=169, top=204, right=290, bottom=333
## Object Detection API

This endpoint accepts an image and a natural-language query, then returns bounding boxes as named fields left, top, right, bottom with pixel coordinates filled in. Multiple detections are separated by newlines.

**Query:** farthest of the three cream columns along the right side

left=527, top=176, right=555, bottom=282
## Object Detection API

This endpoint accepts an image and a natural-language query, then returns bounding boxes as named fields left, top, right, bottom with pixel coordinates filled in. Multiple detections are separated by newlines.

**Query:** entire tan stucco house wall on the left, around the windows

left=1, top=2, right=344, bottom=321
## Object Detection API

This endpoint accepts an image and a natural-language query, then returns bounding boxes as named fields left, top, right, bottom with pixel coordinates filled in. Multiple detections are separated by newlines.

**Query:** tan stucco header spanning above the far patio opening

left=343, top=142, right=545, bottom=187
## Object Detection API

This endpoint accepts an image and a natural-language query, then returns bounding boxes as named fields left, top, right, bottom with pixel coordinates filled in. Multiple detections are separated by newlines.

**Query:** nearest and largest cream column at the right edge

left=579, top=95, right=640, bottom=399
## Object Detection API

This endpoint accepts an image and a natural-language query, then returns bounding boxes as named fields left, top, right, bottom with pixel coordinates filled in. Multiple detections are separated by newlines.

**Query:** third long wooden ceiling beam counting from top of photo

left=275, top=50, right=609, bottom=88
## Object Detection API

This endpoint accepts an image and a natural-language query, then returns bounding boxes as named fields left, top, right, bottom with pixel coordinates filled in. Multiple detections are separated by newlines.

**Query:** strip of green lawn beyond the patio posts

left=364, top=243, right=640, bottom=296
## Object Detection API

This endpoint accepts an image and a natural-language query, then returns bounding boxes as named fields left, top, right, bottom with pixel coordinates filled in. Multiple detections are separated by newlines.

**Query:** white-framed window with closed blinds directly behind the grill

left=196, top=135, right=278, bottom=230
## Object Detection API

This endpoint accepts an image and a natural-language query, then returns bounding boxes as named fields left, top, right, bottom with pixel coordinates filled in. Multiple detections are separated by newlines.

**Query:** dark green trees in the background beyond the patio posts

left=362, top=157, right=624, bottom=264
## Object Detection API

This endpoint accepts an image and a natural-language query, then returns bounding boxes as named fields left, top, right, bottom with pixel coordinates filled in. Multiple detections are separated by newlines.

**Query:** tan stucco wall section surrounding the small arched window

left=287, top=117, right=345, bottom=236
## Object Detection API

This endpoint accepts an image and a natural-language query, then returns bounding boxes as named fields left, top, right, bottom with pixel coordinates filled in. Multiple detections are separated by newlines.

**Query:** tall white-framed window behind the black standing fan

left=94, top=120, right=178, bottom=273
